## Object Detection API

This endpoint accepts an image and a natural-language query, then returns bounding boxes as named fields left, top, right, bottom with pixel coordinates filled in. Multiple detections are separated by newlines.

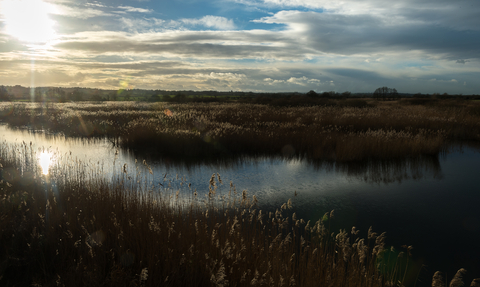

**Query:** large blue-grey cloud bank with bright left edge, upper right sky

left=256, top=11, right=480, bottom=60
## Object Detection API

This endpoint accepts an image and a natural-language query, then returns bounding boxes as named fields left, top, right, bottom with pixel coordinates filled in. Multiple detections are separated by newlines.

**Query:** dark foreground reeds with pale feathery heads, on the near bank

left=0, top=143, right=477, bottom=286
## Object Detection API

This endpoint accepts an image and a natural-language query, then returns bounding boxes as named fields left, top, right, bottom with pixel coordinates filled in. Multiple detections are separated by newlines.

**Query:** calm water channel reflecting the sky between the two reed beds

left=0, top=126, right=480, bottom=286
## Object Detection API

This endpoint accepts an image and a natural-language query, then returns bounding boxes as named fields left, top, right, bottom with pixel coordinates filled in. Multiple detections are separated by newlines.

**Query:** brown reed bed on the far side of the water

left=0, top=100, right=480, bottom=162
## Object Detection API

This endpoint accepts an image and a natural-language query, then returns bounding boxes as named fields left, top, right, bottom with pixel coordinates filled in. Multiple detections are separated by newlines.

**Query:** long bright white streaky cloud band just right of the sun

left=54, top=31, right=307, bottom=59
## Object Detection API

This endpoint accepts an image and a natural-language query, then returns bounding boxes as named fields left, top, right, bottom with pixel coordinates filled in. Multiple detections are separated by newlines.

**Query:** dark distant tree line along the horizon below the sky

left=0, top=85, right=480, bottom=105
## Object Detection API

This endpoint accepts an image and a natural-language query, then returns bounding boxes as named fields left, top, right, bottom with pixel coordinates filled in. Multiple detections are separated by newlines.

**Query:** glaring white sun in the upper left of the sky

left=0, top=0, right=55, bottom=43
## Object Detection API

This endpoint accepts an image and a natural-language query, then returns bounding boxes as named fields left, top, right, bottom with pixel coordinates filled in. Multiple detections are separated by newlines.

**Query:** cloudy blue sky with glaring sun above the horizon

left=0, top=0, right=480, bottom=95
